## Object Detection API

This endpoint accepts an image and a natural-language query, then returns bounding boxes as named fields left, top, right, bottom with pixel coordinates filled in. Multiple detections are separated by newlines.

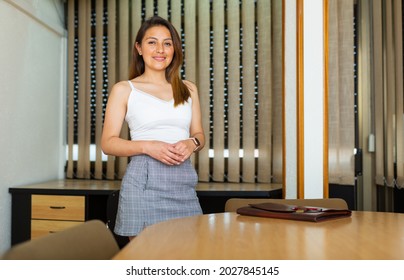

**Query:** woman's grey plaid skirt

left=114, top=155, right=202, bottom=236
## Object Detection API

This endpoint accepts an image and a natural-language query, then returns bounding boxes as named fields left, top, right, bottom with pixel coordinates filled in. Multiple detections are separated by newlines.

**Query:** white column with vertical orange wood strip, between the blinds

left=283, top=0, right=324, bottom=198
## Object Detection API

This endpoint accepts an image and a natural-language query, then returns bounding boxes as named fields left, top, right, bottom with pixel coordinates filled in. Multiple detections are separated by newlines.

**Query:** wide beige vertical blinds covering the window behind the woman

left=66, top=0, right=283, bottom=183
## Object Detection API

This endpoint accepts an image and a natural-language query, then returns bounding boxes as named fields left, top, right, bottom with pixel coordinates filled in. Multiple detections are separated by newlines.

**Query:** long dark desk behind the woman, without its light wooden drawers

left=9, top=179, right=282, bottom=245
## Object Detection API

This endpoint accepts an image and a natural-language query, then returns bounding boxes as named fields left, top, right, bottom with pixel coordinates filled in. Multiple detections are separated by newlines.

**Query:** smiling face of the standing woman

left=136, top=26, right=174, bottom=71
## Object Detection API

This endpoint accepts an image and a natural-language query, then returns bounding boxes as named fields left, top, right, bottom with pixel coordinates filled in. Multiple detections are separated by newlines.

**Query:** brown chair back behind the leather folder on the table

left=224, top=198, right=348, bottom=212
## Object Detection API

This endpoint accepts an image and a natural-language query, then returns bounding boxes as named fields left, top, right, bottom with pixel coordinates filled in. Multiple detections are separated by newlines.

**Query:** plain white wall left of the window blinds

left=0, top=0, right=66, bottom=254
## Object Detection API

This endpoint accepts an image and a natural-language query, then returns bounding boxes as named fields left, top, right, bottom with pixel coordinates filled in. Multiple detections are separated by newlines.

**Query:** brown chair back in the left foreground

left=2, top=220, right=119, bottom=260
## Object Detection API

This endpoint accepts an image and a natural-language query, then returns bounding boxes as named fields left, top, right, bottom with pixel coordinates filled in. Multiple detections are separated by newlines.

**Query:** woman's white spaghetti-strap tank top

left=125, top=81, right=192, bottom=143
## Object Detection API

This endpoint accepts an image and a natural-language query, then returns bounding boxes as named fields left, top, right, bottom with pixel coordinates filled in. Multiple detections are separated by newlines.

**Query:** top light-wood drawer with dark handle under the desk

left=31, top=195, right=85, bottom=221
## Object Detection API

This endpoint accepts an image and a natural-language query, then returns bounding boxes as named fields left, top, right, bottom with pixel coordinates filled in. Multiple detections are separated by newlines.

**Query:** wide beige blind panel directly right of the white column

left=328, top=0, right=355, bottom=185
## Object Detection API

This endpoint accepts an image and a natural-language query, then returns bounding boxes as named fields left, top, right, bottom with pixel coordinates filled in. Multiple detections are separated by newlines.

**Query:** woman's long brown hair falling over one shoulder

left=129, top=16, right=190, bottom=106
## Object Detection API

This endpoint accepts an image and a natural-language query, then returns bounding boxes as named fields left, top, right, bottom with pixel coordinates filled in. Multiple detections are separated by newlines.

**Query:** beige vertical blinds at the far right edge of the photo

left=371, top=0, right=404, bottom=188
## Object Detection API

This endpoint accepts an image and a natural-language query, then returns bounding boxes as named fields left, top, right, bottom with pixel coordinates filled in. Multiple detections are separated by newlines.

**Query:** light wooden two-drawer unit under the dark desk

left=31, top=194, right=85, bottom=239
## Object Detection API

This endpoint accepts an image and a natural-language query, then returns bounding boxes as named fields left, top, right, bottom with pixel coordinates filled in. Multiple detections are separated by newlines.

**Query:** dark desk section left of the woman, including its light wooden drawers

left=9, top=180, right=120, bottom=245
